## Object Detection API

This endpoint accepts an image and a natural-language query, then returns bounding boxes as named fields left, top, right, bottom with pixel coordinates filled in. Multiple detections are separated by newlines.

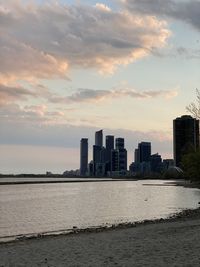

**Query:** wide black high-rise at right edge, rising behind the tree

left=173, top=115, right=199, bottom=167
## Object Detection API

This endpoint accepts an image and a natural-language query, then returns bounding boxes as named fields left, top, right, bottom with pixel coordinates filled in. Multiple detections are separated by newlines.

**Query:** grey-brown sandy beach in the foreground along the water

left=0, top=209, right=200, bottom=267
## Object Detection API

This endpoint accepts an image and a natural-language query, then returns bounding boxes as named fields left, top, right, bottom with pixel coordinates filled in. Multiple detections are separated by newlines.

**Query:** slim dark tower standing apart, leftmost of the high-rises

left=80, top=138, right=88, bottom=176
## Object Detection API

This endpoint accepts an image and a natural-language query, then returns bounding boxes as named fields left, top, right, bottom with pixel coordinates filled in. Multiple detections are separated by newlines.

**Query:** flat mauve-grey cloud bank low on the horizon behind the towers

left=0, top=123, right=172, bottom=173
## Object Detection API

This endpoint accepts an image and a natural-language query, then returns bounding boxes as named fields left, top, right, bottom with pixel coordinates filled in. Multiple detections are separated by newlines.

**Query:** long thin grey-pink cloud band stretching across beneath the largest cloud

left=0, top=79, right=178, bottom=110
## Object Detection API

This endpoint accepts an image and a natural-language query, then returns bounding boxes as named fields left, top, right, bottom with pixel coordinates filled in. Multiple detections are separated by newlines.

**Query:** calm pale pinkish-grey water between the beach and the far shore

left=0, top=180, right=200, bottom=241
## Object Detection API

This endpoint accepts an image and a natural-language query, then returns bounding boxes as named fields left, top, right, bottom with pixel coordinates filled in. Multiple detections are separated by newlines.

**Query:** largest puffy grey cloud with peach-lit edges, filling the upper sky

left=0, top=0, right=170, bottom=83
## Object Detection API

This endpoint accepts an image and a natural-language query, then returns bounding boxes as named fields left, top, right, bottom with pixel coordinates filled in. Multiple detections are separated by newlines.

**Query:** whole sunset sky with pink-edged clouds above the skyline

left=0, top=0, right=200, bottom=173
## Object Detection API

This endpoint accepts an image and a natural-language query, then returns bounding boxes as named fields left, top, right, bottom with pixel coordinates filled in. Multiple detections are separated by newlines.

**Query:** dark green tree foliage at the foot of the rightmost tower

left=182, top=150, right=200, bottom=181
